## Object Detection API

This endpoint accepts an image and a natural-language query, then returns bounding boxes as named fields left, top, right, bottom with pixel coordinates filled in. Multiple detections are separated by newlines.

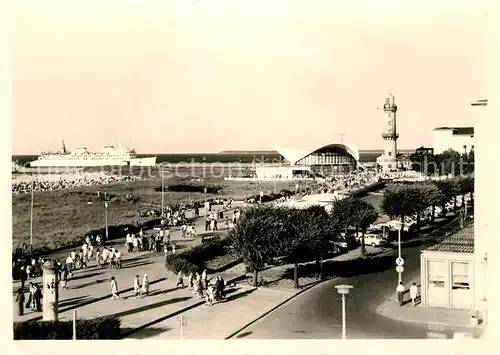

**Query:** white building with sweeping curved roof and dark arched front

left=256, top=142, right=359, bottom=180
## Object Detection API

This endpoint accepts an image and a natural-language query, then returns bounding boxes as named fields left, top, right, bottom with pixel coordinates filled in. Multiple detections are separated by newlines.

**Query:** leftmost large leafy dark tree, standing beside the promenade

left=228, top=206, right=280, bottom=287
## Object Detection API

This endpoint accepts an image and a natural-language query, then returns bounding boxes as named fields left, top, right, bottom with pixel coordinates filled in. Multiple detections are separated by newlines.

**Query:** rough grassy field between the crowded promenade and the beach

left=12, top=178, right=295, bottom=248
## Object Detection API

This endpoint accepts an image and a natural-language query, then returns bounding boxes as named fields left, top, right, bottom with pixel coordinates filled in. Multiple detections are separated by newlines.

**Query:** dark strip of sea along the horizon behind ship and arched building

left=12, top=150, right=406, bottom=165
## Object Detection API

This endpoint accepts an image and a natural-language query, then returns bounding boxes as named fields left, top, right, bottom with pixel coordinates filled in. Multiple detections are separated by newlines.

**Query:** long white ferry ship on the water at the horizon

left=30, top=141, right=156, bottom=168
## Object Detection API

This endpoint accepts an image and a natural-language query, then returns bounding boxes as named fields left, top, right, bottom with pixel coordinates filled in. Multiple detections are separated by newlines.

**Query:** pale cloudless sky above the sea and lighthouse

left=12, top=0, right=487, bottom=154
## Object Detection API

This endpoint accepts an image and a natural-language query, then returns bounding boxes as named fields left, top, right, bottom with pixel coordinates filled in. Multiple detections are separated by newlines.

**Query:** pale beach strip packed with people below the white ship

left=12, top=172, right=148, bottom=194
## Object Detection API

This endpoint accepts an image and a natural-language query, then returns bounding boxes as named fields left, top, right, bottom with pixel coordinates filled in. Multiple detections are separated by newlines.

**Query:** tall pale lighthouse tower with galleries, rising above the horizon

left=380, top=93, right=399, bottom=171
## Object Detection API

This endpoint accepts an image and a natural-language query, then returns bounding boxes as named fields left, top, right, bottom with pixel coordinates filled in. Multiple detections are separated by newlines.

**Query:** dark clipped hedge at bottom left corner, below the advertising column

left=14, top=316, right=121, bottom=340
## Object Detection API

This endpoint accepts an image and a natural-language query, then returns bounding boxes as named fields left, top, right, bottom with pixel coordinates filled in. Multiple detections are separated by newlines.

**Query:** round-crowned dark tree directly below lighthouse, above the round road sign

left=381, top=185, right=424, bottom=231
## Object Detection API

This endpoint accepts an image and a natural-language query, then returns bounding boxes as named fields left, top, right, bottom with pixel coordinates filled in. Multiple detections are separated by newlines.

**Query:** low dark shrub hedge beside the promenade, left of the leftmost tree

left=165, top=238, right=231, bottom=274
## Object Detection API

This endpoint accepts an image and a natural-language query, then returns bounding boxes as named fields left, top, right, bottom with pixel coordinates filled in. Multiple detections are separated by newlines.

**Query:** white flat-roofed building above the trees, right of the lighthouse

left=433, top=127, right=474, bottom=154
